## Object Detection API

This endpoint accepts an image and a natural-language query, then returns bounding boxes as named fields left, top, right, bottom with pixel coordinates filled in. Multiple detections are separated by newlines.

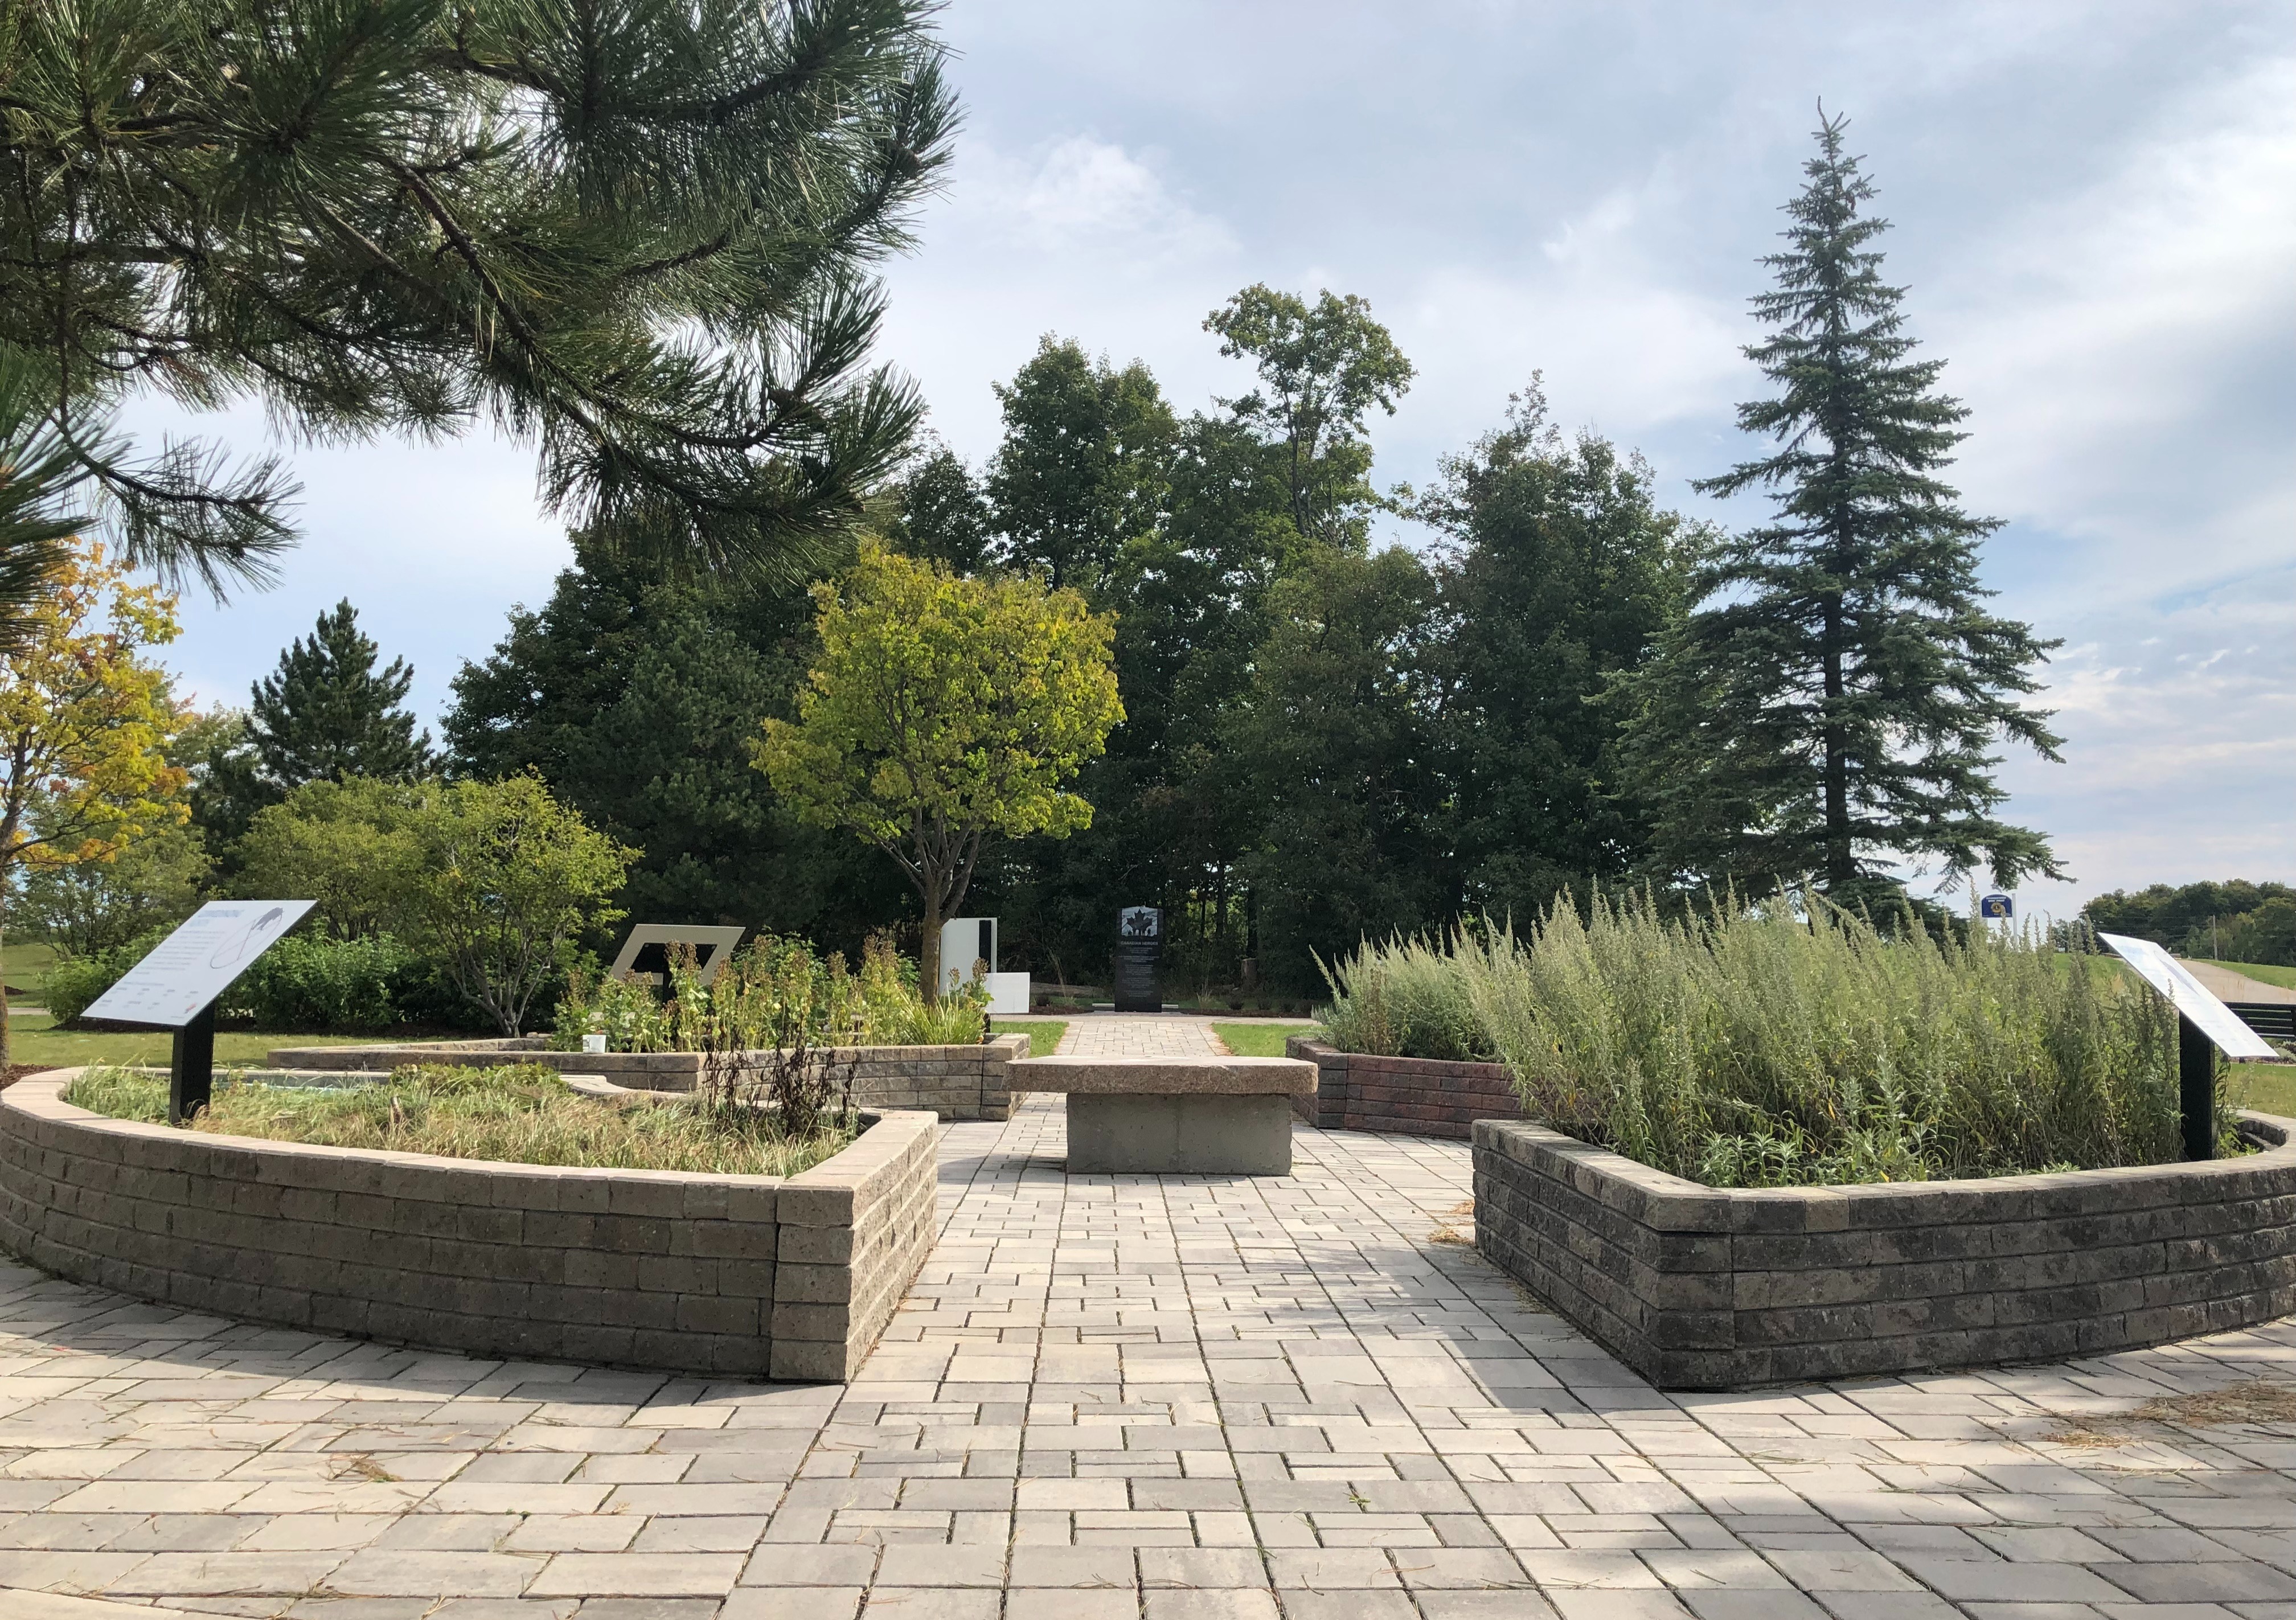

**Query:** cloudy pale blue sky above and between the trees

left=148, top=0, right=2296, bottom=913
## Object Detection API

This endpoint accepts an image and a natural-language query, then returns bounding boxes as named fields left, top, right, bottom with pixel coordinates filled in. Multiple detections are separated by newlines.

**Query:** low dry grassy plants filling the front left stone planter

left=64, top=1065, right=854, bottom=1175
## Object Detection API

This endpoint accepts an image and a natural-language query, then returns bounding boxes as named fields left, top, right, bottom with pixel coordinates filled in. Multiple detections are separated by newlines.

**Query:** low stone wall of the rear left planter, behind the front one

left=269, top=1035, right=1028, bottom=1120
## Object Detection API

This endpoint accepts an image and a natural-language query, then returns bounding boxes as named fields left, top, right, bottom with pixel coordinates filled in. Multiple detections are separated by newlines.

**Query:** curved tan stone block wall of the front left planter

left=0, top=1069, right=937, bottom=1379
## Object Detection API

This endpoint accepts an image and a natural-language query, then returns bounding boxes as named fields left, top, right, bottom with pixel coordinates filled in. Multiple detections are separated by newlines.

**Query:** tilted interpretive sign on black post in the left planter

left=80, top=900, right=317, bottom=1125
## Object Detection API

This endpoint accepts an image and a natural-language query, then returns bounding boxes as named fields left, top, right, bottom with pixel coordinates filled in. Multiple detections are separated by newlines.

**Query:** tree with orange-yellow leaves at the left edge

left=0, top=542, right=188, bottom=1063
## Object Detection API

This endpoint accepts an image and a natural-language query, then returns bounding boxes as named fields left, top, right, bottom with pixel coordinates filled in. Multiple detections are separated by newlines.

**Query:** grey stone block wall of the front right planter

left=1474, top=1115, right=2296, bottom=1388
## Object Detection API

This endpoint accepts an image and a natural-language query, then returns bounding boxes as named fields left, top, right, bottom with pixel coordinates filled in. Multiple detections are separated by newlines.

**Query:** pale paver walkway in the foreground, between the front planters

left=0, top=1097, right=2296, bottom=1620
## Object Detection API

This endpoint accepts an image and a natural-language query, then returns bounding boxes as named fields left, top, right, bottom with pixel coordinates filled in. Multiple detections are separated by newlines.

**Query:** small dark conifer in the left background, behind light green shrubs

left=248, top=601, right=429, bottom=791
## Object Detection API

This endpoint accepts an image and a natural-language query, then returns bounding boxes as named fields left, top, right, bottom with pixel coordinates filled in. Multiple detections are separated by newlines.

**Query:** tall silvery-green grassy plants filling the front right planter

left=1451, top=895, right=2181, bottom=1186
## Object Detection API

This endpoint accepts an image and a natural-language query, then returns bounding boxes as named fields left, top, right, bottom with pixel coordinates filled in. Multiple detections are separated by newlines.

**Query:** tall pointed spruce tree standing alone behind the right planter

left=1621, top=112, right=2060, bottom=900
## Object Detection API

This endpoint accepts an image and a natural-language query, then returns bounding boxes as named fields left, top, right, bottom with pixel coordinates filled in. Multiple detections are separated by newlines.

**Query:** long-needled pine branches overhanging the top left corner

left=0, top=0, right=955, bottom=606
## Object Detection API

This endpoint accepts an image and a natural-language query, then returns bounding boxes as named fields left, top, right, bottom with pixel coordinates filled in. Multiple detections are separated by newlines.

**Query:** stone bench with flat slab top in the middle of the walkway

left=1010, top=1058, right=1315, bottom=1175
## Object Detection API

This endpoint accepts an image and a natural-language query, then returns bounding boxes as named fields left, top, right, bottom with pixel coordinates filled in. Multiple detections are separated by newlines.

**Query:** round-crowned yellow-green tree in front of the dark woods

left=758, top=544, right=1125, bottom=998
